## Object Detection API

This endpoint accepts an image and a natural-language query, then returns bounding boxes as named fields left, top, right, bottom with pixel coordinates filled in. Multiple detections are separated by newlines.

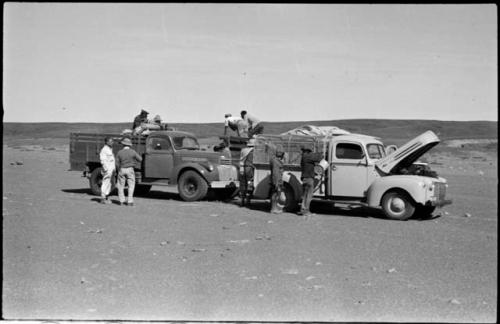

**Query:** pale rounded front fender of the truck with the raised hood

left=366, top=175, right=432, bottom=207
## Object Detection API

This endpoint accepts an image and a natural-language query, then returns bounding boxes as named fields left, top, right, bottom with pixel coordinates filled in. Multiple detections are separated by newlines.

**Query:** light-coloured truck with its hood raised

left=233, top=131, right=452, bottom=220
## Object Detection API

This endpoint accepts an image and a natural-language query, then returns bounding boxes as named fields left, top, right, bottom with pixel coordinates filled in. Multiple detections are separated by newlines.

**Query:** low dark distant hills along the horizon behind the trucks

left=3, top=119, right=498, bottom=144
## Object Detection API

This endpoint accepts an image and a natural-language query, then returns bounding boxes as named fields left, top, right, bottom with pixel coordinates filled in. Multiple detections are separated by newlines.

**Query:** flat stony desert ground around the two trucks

left=2, top=135, right=498, bottom=323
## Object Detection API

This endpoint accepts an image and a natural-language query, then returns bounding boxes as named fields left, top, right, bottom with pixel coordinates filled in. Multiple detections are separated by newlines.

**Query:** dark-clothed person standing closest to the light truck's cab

left=298, top=145, right=323, bottom=216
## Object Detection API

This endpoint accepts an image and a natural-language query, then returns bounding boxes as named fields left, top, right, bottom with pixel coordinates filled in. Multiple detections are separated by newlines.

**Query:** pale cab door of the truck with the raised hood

left=328, top=140, right=368, bottom=199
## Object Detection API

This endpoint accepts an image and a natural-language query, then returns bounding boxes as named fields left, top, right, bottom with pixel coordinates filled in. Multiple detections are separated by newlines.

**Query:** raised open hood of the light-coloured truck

left=375, top=131, right=440, bottom=174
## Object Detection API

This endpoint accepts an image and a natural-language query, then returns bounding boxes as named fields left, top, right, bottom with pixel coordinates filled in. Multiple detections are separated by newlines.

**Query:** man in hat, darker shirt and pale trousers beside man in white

left=116, top=138, right=142, bottom=206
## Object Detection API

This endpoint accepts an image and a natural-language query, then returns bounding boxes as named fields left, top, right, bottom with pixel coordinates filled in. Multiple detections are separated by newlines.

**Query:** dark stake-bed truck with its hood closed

left=69, top=130, right=239, bottom=201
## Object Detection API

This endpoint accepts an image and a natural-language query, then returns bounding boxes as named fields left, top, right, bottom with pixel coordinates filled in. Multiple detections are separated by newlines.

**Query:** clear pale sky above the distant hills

left=2, top=2, right=498, bottom=123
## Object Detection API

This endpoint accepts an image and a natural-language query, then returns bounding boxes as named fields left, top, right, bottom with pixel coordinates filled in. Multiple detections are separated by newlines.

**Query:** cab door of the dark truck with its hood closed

left=144, top=136, right=174, bottom=179
